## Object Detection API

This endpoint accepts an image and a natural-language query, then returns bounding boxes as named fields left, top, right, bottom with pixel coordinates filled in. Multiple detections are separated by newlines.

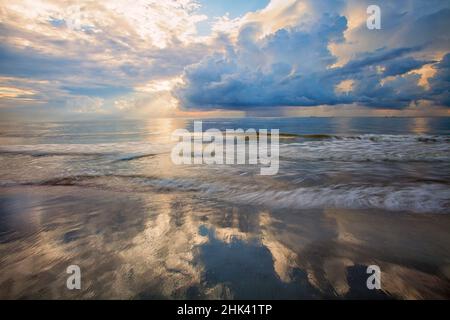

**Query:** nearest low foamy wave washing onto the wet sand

left=3, top=175, right=450, bottom=213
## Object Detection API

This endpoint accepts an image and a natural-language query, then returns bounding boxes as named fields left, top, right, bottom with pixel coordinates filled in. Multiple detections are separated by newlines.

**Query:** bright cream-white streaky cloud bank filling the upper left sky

left=0, top=0, right=208, bottom=112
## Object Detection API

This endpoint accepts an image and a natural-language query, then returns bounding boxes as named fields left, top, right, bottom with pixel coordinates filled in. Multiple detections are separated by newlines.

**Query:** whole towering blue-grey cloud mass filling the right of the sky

left=176, top=1, right=450, bottom=110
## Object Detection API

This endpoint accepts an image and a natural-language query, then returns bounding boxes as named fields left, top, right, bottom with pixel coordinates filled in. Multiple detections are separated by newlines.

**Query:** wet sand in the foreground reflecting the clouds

left=0, top=186, right=450, bottom=299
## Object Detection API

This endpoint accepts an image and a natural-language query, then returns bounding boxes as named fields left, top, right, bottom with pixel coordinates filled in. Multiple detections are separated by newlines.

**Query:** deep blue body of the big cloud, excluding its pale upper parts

left=177, top=29, right=430, bottom=109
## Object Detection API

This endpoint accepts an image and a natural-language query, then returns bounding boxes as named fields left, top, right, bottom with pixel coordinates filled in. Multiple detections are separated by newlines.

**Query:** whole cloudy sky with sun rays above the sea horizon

left=0, top=0, right=450, bottom=120
